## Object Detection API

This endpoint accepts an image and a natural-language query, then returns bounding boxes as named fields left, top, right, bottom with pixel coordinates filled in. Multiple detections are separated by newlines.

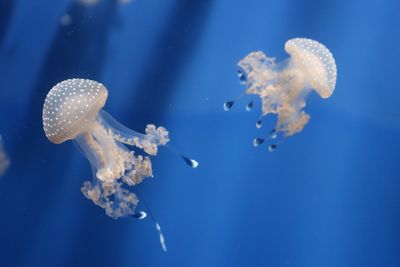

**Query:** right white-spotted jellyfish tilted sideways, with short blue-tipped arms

left=224, top=38, right=336, bottom=151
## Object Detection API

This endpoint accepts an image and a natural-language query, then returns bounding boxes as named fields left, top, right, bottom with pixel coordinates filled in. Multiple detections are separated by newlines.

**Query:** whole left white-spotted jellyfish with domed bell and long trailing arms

left=43, top=79, right=198, bottom=252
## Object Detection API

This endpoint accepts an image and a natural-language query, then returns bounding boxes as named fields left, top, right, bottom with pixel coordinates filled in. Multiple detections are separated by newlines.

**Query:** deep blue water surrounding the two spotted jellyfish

left=0, top=0, right=400, bottom=267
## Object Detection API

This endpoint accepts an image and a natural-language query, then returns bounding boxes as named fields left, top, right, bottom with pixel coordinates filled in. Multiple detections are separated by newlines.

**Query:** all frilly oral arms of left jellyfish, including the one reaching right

left=74, top=108, right=198, bottom=221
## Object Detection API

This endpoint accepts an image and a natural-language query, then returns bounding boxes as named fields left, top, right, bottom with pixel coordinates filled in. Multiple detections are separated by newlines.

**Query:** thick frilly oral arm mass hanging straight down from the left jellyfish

left=74, top=116, right=153, bottom=219
